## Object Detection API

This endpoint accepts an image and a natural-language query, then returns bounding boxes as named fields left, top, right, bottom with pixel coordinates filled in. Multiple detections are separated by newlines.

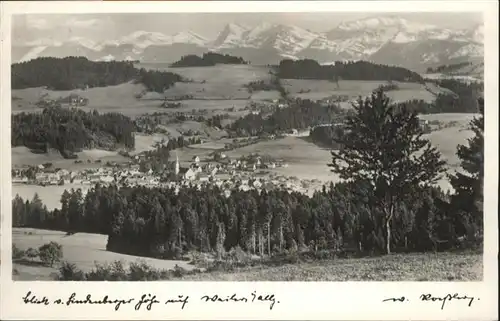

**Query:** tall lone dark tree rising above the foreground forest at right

left=328, top=90, right=445, bottom=254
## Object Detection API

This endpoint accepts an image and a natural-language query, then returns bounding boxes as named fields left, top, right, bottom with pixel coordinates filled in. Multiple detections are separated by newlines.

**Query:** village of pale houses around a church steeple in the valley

left=12, top=151, right=316, bottom=196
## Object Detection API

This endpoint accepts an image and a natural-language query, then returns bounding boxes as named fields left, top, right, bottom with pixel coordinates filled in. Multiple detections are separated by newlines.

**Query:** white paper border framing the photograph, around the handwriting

left=0, top=0, right=498, bottom=320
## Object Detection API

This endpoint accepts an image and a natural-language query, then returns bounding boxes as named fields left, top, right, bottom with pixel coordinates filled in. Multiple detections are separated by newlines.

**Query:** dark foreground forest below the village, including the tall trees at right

left=13, top=92, right=484, bottom=258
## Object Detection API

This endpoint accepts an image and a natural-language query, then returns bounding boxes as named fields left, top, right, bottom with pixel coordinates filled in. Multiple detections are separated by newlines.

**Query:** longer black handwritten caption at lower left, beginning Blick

left=22, top=291, right=280, bottom=311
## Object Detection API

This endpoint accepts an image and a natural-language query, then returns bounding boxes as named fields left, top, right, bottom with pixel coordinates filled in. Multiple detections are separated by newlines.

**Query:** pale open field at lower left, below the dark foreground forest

left=12, top=228, right=194, bottom=280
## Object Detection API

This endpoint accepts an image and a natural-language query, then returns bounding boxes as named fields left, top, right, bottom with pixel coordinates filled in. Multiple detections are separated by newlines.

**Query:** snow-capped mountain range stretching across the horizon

left=12, top=16, right=484, bottom=71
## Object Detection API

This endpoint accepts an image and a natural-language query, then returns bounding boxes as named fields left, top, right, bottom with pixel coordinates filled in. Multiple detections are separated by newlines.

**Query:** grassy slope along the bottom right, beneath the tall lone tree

left=182, top=253, right=483, bottom=281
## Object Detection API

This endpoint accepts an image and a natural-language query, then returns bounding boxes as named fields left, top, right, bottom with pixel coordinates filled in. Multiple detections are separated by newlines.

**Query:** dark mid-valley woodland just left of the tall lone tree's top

left=227, top=99, right=345, bottom=136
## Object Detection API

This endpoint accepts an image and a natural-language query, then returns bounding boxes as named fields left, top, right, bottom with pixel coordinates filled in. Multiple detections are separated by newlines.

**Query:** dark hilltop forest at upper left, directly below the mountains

left=11, top=57, right=181, bottom=92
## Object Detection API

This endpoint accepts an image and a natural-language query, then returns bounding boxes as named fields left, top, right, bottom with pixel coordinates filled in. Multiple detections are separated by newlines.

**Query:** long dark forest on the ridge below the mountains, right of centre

left=277, top=59, right=423, bottom=82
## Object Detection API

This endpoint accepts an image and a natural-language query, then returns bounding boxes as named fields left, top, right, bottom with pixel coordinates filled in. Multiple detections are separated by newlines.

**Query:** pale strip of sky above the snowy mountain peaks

left=12, top=12, right=482, bottom=44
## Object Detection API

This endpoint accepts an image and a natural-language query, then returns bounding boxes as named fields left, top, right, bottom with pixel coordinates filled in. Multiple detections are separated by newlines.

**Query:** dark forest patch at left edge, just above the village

left=11, top=107, right=135, bottom=158
